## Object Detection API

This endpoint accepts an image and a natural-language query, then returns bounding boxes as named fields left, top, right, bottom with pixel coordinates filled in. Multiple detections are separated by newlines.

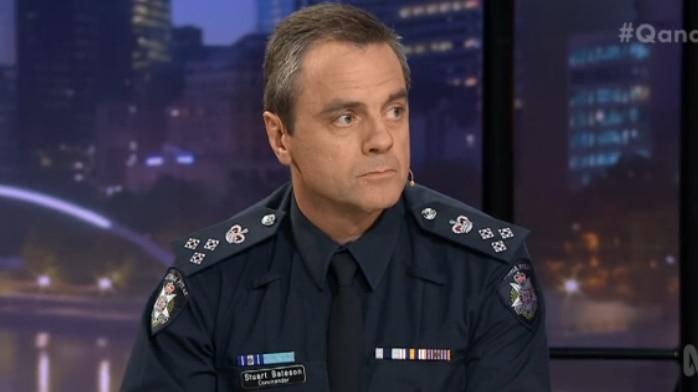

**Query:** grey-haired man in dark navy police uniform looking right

left=122, top=4, right=550, bottom=392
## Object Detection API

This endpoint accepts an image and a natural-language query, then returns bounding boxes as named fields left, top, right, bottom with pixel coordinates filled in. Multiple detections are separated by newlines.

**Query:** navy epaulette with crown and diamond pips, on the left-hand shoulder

left=170, top=207, right=285, bottom=276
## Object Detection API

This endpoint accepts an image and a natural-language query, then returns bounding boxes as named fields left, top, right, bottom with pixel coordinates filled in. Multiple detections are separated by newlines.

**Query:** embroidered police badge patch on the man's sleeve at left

left=150, top=268, right=189, bottom=334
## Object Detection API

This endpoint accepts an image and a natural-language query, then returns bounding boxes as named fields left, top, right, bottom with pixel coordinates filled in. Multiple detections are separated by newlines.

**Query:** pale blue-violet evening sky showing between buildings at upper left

left=0, top=0, right=256, bottom=64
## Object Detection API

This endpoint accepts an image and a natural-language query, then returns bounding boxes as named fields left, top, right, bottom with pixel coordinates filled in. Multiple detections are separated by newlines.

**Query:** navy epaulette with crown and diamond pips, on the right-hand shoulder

left=412, top=201, right=529, bottom=263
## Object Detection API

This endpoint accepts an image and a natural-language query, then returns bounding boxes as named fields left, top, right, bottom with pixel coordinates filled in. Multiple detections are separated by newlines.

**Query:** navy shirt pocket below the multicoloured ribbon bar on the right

left=369, top=358, right=466, bottom=392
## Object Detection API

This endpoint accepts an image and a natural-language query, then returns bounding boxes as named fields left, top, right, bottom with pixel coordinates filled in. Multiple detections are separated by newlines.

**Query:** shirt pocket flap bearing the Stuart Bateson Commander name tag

left=218, top=361, right=330, bottom=392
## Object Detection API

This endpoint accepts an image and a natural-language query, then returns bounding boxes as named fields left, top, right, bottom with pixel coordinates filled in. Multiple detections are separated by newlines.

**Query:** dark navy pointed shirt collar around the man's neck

left=290, top=193, right=404, bottom=290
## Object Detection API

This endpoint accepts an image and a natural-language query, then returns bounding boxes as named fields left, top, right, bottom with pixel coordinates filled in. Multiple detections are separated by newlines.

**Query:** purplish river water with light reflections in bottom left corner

left=0, top=327, right=132, bottom=392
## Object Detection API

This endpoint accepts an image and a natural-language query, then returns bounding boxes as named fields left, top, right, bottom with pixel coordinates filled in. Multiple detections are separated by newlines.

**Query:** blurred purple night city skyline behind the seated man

left=0, top=0, right=681, bottom=392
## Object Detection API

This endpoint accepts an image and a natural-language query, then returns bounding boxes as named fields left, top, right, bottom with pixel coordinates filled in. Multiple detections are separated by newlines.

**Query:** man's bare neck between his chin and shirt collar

left=294, top=188, right=383, bottom=244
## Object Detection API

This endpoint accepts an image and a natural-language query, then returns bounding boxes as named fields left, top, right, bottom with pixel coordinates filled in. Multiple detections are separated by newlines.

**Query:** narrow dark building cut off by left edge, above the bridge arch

left=0, top=65, right=18, bottom=181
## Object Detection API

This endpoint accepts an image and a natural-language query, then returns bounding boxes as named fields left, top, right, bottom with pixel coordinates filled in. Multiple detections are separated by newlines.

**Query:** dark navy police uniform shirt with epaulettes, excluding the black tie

left=121, top=185, right=551, bottom=392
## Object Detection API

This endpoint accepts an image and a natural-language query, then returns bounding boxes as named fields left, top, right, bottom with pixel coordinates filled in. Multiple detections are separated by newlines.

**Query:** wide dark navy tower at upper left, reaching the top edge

left=16, top=0, right=100, bottom=158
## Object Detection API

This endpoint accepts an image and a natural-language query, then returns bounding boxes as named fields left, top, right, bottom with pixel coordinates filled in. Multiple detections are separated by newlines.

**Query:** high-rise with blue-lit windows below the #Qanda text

left=568, top=24, right=680, bottom=190
